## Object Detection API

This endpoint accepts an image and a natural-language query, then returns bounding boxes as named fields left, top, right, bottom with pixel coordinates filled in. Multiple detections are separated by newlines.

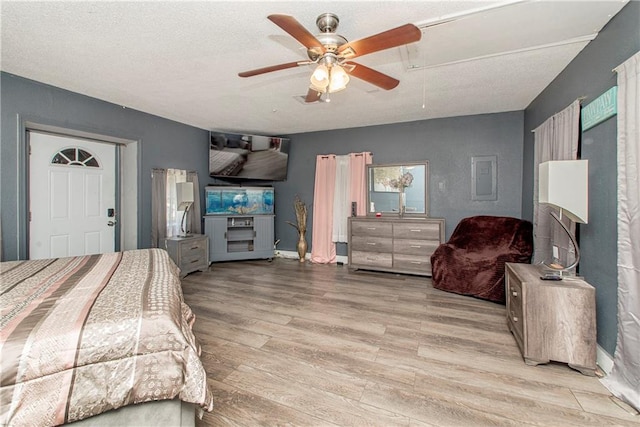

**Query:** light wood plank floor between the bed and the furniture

left=183, top=258, right=640, bottom=427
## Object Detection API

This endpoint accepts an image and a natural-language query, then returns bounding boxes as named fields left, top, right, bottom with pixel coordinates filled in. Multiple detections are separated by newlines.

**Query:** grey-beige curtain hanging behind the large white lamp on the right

left=533, top=100, right=580, bottom=265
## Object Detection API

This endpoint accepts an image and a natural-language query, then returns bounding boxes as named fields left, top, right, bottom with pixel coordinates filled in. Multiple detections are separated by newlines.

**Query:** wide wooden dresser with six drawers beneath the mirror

left=349, top=217, right=444, bottom=276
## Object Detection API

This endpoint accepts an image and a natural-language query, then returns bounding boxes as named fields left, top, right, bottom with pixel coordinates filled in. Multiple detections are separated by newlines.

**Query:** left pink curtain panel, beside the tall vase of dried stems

left=311, top=154, right=336, bottom=264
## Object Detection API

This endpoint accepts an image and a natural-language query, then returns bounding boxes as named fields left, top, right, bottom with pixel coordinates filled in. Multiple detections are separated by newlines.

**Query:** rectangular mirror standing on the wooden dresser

left=367, top=161, right=429, bottom=216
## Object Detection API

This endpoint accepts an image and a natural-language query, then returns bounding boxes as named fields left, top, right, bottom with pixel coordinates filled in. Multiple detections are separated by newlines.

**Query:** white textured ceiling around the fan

left=0, top=0, right=626, bottom=135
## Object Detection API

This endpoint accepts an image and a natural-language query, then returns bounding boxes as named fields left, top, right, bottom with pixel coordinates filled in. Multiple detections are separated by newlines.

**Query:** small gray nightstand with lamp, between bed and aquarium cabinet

left=164, top=234, right=209, bottom=277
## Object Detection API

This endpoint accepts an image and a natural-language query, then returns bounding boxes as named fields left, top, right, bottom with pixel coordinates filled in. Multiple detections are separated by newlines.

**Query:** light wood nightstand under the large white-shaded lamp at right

left=505, top=263, right=597, bottom=376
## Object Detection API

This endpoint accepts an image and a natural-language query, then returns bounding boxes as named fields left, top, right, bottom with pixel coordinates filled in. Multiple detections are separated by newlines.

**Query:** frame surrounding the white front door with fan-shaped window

left=16, top=115, right=141, bottom=259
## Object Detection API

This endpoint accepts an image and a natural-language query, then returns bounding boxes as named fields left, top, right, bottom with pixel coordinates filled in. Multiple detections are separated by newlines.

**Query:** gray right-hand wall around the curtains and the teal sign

left=522, top=1, right=640, bottom=354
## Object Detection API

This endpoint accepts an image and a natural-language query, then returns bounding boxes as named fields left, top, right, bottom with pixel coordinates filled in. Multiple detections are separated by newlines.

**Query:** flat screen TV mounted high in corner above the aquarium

left=209, top=132, right=289, bottom=181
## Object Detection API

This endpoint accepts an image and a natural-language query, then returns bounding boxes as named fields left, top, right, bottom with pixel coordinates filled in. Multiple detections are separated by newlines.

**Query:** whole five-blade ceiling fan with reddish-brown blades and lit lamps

left=238, top=13, right=422, bottom=102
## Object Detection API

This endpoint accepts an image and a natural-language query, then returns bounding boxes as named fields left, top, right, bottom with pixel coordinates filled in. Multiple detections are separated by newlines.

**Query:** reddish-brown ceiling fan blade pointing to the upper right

left=338, top=24, right=422, bottom=59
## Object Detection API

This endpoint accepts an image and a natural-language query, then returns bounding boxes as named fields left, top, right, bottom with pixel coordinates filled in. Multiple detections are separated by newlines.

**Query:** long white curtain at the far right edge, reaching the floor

left=602, top=52, right=640, bottom=411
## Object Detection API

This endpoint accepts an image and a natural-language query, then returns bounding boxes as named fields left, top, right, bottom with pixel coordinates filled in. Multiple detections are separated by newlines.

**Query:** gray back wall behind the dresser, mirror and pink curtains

left=275, top=111, right=524, bottom=255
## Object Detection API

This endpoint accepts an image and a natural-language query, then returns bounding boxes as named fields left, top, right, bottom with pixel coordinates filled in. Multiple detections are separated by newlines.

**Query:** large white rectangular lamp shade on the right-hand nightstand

left=538, top=160, right=589, bottom=224
